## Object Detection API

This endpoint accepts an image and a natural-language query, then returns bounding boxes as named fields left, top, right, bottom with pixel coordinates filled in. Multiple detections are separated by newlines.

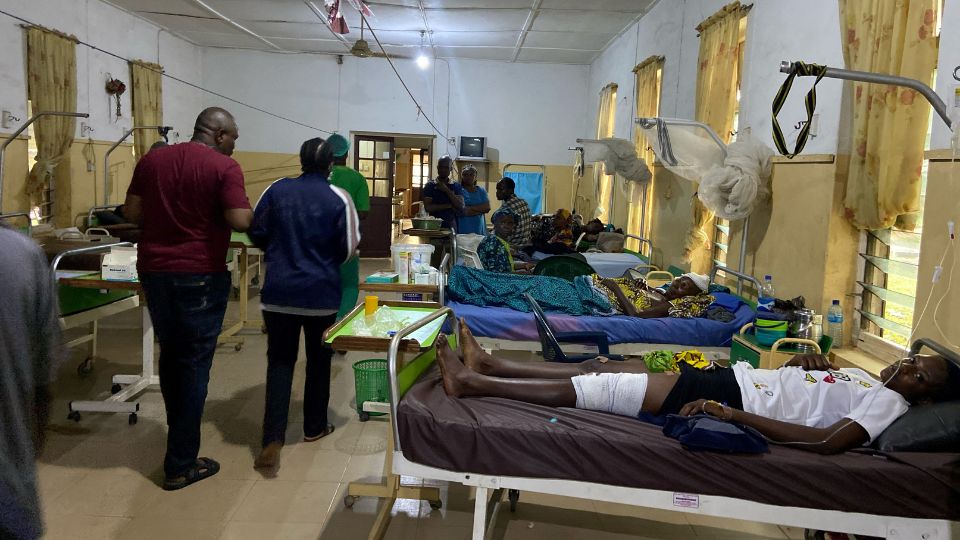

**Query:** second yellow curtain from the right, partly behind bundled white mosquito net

left=683, top=2, right=748, bottom=272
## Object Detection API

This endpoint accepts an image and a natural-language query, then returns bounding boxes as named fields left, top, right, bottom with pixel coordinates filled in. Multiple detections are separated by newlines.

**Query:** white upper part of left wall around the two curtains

left=0, top=0, right=202, bottom=140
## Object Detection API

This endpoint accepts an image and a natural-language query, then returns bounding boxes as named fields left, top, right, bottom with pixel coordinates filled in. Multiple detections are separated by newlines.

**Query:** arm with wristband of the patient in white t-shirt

left=680, top=399, right=870, bottom=454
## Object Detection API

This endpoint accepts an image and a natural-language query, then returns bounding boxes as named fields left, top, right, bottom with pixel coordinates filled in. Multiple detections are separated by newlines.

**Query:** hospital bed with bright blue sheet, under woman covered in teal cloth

left=447, top=267, right=759, bottom=360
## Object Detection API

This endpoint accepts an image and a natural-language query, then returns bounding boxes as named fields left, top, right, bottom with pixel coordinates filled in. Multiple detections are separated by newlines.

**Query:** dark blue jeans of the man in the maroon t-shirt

left=140, top=272, right=230, bottom=478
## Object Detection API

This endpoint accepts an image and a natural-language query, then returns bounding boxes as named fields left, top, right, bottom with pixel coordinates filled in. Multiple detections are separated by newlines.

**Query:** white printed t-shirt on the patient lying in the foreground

left=733, top=362, right=909, bottom=441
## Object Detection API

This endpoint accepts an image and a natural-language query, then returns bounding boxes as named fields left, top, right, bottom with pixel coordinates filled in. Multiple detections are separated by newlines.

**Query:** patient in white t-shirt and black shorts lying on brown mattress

left=437, top=319, right=960, bottom=454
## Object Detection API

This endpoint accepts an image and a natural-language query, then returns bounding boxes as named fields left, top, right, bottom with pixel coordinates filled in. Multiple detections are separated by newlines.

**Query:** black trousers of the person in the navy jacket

left=263, top=311, right=337, bottom=446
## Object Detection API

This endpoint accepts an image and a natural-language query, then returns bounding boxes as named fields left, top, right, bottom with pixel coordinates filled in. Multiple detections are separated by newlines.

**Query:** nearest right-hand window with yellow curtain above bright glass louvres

left=852, top=0, right=949, bottom=359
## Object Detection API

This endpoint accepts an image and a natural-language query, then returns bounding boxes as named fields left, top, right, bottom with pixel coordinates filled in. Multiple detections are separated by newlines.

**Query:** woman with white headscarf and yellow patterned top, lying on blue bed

left=591, top=272, right=715, bottom=319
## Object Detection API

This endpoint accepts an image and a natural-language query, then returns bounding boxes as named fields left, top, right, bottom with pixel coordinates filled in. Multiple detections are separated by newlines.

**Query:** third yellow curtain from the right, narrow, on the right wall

left=627, top=56, right=664, bottom=250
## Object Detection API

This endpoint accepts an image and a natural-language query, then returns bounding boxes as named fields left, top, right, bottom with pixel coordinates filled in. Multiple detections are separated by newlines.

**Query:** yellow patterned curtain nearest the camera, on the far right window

left=840, top=0, right=940, bottom=230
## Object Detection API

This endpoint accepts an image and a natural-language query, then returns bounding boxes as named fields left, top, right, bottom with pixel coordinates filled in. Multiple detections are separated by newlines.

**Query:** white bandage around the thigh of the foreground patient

left=570, top=373, right=647, bottom=417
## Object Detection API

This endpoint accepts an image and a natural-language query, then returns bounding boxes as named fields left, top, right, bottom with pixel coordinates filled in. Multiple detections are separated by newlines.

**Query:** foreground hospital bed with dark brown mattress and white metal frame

left=386, top=308, right=960, bottom=540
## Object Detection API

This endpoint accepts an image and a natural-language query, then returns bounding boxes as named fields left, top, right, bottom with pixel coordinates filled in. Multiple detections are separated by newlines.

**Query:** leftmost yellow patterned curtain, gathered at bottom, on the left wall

left=26, top=26, right=77, bottom=222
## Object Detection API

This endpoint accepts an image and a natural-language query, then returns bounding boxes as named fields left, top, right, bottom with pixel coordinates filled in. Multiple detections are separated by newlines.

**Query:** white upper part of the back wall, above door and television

left=204, top=49, right=588, bottom=164
